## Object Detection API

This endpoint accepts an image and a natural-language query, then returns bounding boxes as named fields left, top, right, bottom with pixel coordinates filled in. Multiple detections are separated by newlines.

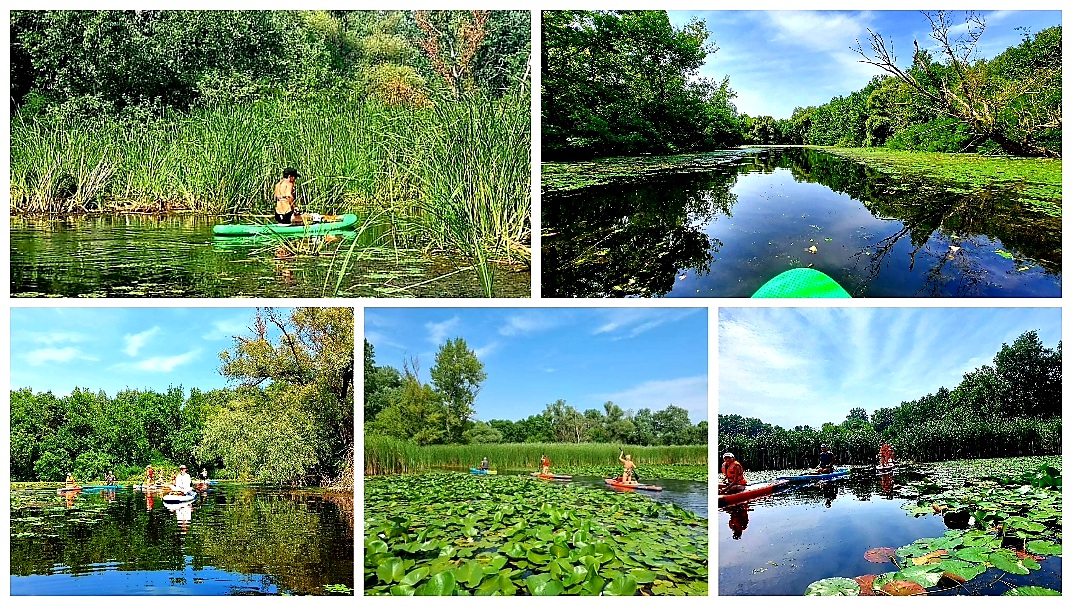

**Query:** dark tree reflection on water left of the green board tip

left=542, top=173, right=736, bottom=297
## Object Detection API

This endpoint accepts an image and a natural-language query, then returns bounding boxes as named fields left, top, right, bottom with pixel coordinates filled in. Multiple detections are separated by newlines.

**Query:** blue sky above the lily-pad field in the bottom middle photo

left=364, top=308, right=708, bottom=423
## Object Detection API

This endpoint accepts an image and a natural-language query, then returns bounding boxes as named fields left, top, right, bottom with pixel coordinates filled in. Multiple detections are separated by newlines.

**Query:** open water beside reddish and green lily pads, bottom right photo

left=718, top=472, right=1061, bottom=595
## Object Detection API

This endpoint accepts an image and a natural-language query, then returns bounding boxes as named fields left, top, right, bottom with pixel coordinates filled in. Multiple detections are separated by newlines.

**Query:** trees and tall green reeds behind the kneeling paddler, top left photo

left=11, top=11, right=531, bottom=263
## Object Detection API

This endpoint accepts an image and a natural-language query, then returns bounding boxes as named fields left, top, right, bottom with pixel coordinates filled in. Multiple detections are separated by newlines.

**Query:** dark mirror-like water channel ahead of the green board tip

left=541, top=149, right=1061, bottom=297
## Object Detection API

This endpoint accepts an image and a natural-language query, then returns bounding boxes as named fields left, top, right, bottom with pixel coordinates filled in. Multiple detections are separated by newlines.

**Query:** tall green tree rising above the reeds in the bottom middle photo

left=431, top=337, right=488, bottom=442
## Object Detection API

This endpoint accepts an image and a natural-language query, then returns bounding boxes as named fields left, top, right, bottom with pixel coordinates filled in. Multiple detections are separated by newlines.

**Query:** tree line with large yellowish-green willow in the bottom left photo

left=11, top=308, right=354, bottom=488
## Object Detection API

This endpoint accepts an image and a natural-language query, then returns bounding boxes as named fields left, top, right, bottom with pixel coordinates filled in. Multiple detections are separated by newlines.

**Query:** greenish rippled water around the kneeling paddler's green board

left=11, top=215, right=531, bottom=297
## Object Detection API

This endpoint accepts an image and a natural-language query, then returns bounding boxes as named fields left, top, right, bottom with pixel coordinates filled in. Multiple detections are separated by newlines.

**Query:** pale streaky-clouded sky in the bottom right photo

left=718, top=308, right=1061, bottom=428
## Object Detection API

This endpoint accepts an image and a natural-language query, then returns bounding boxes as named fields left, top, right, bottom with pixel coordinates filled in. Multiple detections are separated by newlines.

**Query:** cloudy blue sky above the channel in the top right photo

left=670, top=11, right=1061, bottom=118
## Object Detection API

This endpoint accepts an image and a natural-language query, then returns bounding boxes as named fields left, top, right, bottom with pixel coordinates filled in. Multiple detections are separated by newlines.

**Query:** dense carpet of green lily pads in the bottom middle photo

left=364, top=474, right=708, bottom=595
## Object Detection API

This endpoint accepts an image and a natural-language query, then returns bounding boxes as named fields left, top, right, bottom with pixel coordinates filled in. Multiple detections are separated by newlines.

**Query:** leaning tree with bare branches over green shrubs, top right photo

left=855, top=11, right=1061, bottom=156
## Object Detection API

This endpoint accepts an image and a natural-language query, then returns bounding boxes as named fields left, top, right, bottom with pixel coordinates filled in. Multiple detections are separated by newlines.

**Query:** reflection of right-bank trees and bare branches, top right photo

left=775, top=149, right=1061, bottom=296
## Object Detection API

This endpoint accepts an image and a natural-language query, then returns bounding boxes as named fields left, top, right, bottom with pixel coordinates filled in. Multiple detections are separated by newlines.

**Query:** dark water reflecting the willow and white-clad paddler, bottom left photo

left=11, top=485, right=354, bottom=595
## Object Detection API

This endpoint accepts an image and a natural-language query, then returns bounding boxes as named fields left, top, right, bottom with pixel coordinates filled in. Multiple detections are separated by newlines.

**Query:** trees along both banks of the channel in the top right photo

left=542, top=11, right=1061, bottom=159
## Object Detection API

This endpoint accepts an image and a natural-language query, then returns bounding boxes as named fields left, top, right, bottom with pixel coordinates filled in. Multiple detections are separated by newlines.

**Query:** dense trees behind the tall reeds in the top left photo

left=11, top=11, right=530, bottom=119
